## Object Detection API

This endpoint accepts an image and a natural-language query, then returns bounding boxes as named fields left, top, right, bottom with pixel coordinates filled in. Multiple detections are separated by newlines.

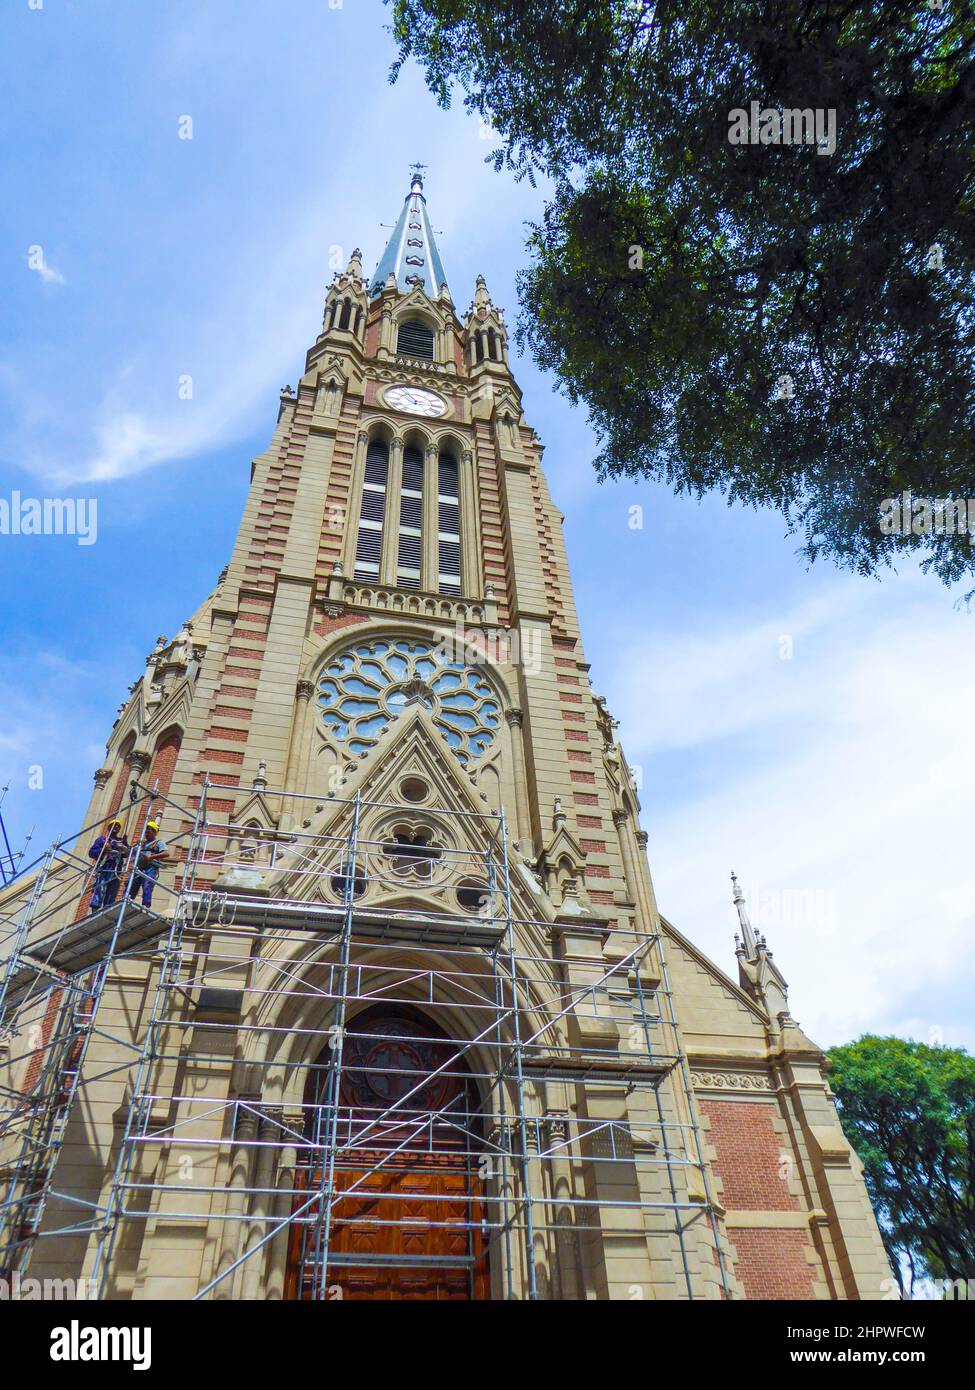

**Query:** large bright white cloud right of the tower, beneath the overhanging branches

left=611, top=580, right=975, bottom=1044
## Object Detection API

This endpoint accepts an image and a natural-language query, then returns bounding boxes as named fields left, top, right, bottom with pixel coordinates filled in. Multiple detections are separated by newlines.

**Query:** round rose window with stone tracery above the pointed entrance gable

left=319, top=639, right=501, bottom=766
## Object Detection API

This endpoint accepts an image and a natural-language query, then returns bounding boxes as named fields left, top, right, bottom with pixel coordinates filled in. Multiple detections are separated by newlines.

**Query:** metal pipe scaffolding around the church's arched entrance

left=0, top=781, right=730, bottom=1300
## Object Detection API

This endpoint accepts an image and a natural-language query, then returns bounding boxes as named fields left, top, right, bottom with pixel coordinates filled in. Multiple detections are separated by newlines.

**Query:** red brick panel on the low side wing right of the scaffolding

left=698, top=1099, right=815, bottom=1298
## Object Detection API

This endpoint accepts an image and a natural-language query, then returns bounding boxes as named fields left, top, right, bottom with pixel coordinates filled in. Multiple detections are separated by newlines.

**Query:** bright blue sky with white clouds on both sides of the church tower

left=0, top=0, right=975, bottom=1047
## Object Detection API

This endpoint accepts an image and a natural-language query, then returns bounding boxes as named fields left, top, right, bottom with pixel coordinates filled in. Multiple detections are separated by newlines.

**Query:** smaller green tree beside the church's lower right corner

left=828, top=1036, right=975, bottom=1280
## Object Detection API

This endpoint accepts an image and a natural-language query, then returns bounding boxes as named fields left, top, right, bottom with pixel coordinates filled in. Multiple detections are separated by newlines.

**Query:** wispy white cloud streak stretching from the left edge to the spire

left=0, top=75, right=539, bottom=487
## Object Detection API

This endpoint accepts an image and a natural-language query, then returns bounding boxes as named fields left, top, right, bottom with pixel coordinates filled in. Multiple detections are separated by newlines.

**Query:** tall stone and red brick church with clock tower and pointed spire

left=0, top=178, right=890, bottom=1301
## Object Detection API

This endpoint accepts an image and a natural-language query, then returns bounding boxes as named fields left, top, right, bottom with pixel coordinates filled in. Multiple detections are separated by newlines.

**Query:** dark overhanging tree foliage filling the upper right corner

left=391, top=0, right=975, bottom=582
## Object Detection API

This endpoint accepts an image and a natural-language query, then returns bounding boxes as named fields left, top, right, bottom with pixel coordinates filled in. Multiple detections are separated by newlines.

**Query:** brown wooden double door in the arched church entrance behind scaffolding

left=289, top=1006, right=490, bottom=1300
